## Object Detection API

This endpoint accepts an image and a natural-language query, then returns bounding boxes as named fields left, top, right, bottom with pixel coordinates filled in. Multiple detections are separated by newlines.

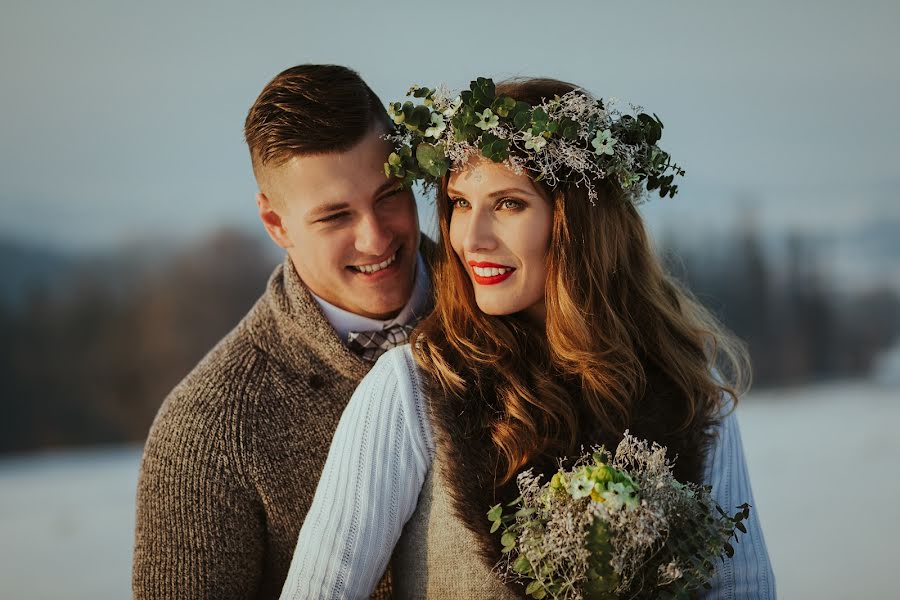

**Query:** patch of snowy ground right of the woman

left=739, top=383, right=900, bottom=600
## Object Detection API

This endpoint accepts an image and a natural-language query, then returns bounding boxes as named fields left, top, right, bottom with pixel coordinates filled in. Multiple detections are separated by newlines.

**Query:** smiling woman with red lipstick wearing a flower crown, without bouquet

left=282, top=79, right=774, bottom=598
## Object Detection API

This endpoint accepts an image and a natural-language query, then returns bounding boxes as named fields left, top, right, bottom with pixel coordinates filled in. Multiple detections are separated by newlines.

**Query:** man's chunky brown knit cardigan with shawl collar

left=132, top=254, right=412, bottom=600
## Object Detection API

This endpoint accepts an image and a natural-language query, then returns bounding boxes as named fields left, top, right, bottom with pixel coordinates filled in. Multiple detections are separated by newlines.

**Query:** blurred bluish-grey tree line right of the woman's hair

left=663, top=220, right=900, bottom=388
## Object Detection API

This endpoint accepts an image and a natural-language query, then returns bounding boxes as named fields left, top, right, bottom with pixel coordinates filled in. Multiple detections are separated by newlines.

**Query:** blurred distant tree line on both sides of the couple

left=0, top=228, right=900, bottom=452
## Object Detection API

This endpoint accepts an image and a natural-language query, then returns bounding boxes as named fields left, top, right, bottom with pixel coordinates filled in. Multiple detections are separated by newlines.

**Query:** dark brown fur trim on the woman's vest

left=429, top=360, right=712, bottom=597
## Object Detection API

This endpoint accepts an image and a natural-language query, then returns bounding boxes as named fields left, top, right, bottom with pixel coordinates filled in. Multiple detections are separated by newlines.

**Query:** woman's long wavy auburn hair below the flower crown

left=412, top=79, right=750, bottom=483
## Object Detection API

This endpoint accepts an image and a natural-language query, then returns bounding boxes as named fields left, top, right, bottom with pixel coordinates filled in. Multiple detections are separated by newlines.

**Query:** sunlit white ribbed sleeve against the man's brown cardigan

left=281, top=345, right=434, bottom=600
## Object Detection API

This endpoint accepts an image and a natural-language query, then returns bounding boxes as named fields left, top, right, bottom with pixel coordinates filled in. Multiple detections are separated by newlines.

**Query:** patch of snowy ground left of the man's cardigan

left=0, top=447, right=140, bottom=600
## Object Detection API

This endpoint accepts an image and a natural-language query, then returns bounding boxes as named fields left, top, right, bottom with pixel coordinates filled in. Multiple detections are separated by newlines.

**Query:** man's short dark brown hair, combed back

left=244, top=65, right=391, bottom=179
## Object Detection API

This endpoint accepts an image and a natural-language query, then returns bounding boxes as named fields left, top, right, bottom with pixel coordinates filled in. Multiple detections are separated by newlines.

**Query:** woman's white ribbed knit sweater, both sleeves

left=281, top=345, right=775, bottom=600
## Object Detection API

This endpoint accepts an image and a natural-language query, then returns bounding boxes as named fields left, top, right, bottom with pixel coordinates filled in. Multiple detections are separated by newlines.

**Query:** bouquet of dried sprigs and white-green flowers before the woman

left=488, top=431, right=750, bottom=600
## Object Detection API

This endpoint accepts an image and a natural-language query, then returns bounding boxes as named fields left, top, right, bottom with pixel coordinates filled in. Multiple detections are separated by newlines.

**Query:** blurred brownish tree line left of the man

left=0, top=231, right=277, bottom=452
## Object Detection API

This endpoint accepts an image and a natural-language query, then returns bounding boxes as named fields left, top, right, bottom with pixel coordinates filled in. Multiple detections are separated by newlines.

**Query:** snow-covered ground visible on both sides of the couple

left=0, top=382, right=900, bottom=600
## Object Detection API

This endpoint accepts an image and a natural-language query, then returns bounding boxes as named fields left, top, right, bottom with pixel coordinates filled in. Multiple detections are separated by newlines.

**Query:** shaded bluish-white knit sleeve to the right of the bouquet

left=703, top=412, right=775, bottom=600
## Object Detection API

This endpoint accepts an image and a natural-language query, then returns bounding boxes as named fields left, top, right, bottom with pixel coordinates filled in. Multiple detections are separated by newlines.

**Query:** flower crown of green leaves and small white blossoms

left=384, top=77, right=684, bottom=203
